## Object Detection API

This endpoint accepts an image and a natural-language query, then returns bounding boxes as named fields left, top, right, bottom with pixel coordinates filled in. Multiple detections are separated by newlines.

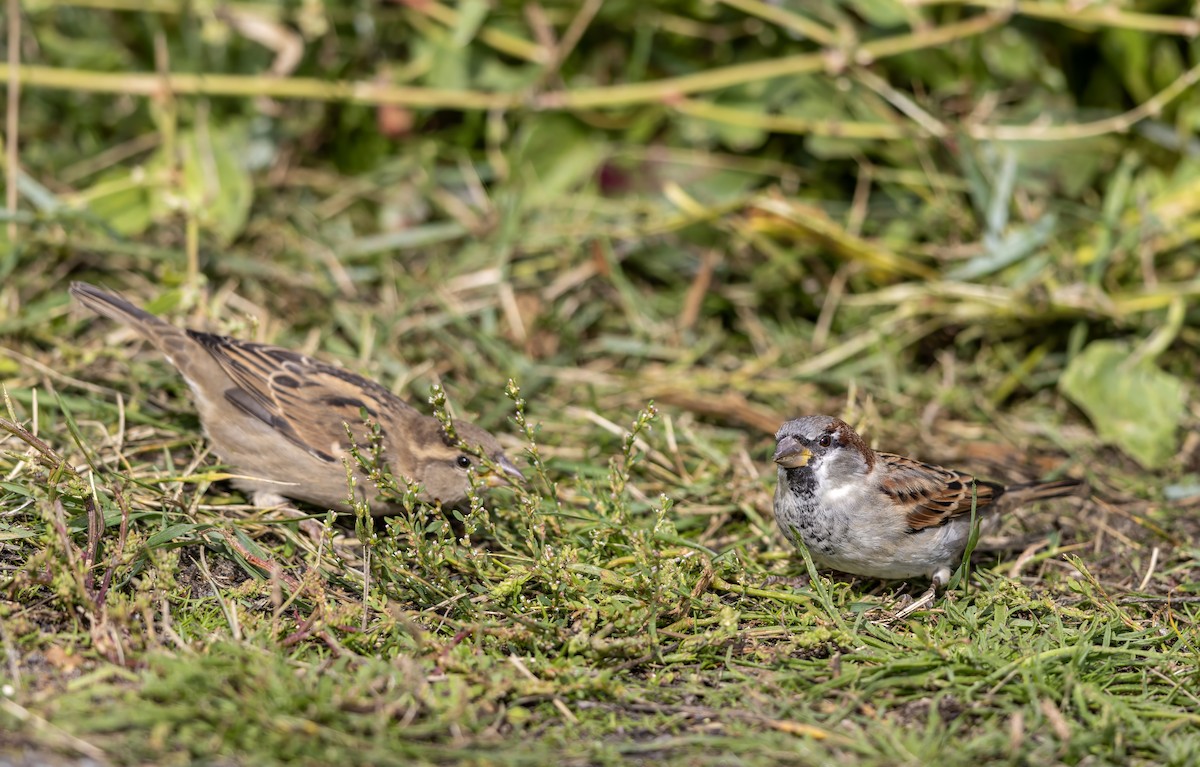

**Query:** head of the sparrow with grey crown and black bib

left=772, top=415, right=875, bottom=475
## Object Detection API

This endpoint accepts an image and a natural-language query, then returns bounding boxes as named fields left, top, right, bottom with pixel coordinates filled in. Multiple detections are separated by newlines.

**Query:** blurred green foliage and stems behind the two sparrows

left=0, top=0, right=1200, bottom=468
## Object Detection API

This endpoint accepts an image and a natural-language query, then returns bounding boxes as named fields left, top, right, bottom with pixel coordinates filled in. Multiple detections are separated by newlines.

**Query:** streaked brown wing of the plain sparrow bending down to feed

left=187, top=330, right=416, bottom=462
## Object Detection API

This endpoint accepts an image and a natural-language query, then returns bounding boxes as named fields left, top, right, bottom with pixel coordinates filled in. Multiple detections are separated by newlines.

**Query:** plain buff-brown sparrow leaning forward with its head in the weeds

left=71, top=282, right=524, bottom=515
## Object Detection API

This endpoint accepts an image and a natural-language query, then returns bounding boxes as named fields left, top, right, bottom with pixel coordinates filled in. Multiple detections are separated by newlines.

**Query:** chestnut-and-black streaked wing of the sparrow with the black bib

left=876, top=453, right=1004, bottom=532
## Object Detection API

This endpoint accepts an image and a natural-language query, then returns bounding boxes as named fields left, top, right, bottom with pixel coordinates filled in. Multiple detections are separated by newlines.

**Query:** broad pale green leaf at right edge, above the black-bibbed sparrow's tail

left=1058, top=341, right=1187, bottom=469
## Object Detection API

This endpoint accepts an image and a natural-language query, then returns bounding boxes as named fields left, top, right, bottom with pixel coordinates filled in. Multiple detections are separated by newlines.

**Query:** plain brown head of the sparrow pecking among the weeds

left=412, top=418, right=524, bottom=505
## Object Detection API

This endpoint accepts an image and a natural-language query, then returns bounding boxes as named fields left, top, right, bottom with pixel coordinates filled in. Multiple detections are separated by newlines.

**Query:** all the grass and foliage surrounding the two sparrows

left=0, top=2, right=1200, bottom=767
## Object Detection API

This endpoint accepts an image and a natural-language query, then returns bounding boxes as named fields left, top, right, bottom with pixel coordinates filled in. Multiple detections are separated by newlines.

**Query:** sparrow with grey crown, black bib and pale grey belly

left=773, top=415, right=1079, bottom=597
